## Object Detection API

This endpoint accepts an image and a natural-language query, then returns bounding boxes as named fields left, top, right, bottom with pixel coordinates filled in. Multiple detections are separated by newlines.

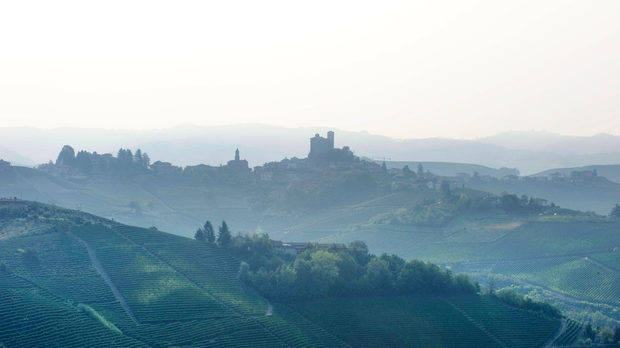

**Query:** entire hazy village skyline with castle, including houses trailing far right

left=0, top=131, right=608, bottom=198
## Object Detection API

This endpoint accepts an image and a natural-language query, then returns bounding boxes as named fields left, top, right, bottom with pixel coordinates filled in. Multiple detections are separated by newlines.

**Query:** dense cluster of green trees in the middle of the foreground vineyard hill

left=223, top=234, right=479, bottom=300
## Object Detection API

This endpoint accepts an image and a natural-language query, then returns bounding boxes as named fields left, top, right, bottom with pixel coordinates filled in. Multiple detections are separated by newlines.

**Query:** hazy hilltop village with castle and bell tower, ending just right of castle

left=30, top=131, right=437, bottom=188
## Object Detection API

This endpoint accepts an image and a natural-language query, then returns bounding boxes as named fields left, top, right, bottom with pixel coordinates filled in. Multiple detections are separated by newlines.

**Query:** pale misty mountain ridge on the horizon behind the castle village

left=0, top=124, right=620, bottom=175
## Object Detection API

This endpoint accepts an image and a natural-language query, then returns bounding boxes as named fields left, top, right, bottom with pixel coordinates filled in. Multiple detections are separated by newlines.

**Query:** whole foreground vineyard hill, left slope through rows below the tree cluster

left=0, top=201, right=560, bottom=347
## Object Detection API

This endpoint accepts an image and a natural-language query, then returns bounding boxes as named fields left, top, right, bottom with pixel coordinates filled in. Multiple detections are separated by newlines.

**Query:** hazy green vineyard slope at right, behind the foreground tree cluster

left=330, top=204, right=620, bottom=326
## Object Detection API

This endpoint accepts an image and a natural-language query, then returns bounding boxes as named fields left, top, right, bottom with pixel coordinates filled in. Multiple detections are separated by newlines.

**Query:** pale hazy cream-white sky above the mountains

left=0, top=0, right=620, bottom=138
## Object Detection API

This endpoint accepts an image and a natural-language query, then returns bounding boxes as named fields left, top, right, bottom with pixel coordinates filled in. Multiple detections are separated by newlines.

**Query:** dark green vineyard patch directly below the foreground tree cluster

left=292, top=296, right=559, bottom=347
